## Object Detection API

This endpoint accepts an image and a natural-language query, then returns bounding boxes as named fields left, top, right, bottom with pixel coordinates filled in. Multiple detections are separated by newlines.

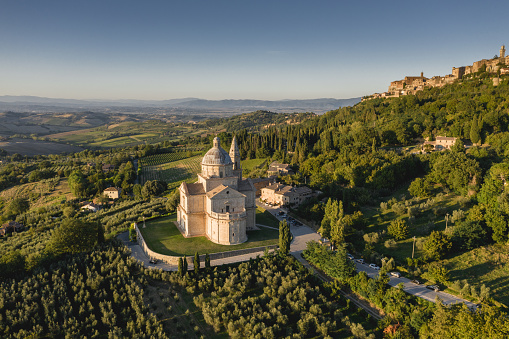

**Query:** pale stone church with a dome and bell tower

left=177, top=137, right=256, bottom=245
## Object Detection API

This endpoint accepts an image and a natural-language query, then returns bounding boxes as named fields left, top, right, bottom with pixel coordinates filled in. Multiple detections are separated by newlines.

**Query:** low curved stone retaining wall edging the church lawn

left=134, top=224, right=278, bottom=266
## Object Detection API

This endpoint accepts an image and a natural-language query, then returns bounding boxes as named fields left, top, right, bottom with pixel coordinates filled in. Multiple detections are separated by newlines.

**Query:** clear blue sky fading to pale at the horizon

left=0, top=0, right=509, bottom=100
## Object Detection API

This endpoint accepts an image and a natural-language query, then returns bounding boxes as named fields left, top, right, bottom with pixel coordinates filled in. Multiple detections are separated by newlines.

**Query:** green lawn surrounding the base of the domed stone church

left=140, top=215, right=279, bottom=256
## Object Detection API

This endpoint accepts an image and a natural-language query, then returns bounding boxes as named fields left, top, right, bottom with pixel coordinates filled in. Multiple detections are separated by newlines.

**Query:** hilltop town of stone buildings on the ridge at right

left=362, top=45, right=509, bottom=101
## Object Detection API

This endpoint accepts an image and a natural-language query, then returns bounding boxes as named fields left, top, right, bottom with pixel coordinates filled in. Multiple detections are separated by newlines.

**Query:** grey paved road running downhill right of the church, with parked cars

left=257, top=202, right=475, bottom=308
